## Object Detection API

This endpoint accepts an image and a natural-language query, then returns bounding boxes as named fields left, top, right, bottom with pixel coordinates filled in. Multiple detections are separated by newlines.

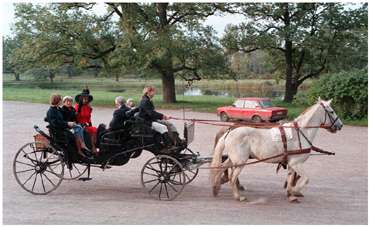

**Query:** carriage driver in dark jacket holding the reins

left=138, top=86, right=186, bottom=148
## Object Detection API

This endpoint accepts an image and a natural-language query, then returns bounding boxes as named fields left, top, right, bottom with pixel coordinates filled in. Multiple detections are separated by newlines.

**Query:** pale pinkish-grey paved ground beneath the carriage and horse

left=3, top=101, right=368, bottom=224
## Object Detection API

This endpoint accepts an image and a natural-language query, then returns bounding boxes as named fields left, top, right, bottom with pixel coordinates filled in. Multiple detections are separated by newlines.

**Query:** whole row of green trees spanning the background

left=3, top=3, right=368, bottom=117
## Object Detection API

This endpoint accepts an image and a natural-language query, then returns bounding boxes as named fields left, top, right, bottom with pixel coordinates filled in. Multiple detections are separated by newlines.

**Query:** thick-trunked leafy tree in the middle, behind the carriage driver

left=107, top=3, right=230, bottom=103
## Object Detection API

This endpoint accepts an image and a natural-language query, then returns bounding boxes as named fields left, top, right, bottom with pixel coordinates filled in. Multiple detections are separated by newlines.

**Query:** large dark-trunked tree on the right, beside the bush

left=222, top=3, right=367, bottom=102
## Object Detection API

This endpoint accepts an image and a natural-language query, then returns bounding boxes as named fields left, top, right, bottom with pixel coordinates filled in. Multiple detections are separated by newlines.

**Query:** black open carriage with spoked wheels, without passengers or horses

left=13, top=118, right=201, bottom=200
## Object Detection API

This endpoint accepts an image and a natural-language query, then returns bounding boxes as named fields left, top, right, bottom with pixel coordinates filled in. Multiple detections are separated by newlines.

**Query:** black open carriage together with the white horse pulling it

left=13, top=99, right=343, bottom=201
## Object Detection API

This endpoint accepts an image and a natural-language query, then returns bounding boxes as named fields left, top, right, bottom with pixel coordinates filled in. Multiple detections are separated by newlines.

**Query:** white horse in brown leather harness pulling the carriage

left=210, top=98, right=343, bottom=202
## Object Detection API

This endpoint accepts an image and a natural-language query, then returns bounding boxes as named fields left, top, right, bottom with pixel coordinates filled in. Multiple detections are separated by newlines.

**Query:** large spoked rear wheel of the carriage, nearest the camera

left=13, top=142, right=64, bottom=195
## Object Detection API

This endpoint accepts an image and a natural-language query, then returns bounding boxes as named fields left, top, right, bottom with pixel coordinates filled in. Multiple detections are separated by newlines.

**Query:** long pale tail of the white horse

left=210, top=135, right=225, bottom=196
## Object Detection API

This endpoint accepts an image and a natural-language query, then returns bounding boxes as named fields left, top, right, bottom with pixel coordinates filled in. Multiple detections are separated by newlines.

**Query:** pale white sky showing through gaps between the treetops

left=0, top=2, right=247, bottom=37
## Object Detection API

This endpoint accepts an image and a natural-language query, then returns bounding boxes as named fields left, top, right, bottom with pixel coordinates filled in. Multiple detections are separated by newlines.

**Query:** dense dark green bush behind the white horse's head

left=306, top=69, right=368, bottom=119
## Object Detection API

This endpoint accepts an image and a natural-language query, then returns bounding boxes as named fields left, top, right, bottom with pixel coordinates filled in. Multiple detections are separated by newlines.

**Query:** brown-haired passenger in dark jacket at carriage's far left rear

left=46, top=94, right=92, bottom=161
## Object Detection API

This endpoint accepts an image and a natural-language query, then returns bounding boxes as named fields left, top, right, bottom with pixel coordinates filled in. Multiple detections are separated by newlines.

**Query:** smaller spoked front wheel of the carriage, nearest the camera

left=141, top=155, right=185, bottom=200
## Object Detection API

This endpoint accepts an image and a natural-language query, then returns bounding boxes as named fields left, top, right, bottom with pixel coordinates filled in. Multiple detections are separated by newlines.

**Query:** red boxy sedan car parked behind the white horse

left=217, top=98, right=288, bottom=122
